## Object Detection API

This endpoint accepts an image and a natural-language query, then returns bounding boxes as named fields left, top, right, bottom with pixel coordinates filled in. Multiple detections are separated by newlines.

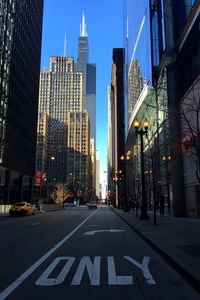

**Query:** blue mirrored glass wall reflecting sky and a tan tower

left=124, top=0, right=151, bottom=128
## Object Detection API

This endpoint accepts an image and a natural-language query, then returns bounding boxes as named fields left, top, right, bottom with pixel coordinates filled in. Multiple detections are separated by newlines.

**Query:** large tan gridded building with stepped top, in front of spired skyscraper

left=36, top=56, right=83, bottom=184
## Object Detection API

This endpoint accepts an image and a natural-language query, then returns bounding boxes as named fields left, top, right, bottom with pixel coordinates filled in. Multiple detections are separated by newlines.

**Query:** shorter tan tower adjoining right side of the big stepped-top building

left=66, top=111, right=91, bottom=195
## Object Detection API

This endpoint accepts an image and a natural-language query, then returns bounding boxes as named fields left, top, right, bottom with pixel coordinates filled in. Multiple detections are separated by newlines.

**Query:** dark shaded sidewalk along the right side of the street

left=113, top=208, right=200, bottom=292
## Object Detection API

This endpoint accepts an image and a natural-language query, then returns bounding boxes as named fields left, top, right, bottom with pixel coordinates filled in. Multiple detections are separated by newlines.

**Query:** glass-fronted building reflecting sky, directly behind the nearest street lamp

left=124, top=0, right=171, bottom=208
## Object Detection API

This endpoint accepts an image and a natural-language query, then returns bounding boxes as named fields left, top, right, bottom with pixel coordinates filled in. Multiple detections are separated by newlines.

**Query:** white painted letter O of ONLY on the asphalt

left=35, top=256, right=75, bottom=286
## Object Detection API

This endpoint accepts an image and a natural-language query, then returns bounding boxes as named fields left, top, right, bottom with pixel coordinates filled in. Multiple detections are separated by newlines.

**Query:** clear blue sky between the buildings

left=41, top=0, right=123, bottom=170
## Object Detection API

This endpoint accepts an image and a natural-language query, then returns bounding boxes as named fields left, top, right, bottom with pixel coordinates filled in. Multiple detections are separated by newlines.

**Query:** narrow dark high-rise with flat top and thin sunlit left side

left=108, top=48, right=125, bottom=207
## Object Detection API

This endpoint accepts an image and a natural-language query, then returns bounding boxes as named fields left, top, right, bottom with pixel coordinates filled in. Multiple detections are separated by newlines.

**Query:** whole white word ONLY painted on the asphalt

left=35, top=256, right=156, bottom=286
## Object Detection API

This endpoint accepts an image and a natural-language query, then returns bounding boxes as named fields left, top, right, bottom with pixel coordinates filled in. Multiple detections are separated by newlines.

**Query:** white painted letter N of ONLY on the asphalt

left=71, top=256, right=101, bottom=285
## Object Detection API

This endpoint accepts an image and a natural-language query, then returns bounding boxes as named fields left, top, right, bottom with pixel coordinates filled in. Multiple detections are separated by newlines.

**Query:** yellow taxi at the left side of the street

left=9, top=202, right=35, bottom=217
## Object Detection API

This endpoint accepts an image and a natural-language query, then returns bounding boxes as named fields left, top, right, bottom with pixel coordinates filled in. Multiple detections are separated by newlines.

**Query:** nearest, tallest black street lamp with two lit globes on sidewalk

left=134, top=119, right=149, bottom=220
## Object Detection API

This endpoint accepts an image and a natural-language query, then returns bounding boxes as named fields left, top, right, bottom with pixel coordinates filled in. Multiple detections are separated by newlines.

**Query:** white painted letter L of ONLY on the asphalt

left=107, top=256, right=133, bottom=285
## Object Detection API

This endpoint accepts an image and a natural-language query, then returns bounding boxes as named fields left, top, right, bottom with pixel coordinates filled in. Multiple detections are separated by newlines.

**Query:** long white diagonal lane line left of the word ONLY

left=0, top=210, right=97, bottom=300
